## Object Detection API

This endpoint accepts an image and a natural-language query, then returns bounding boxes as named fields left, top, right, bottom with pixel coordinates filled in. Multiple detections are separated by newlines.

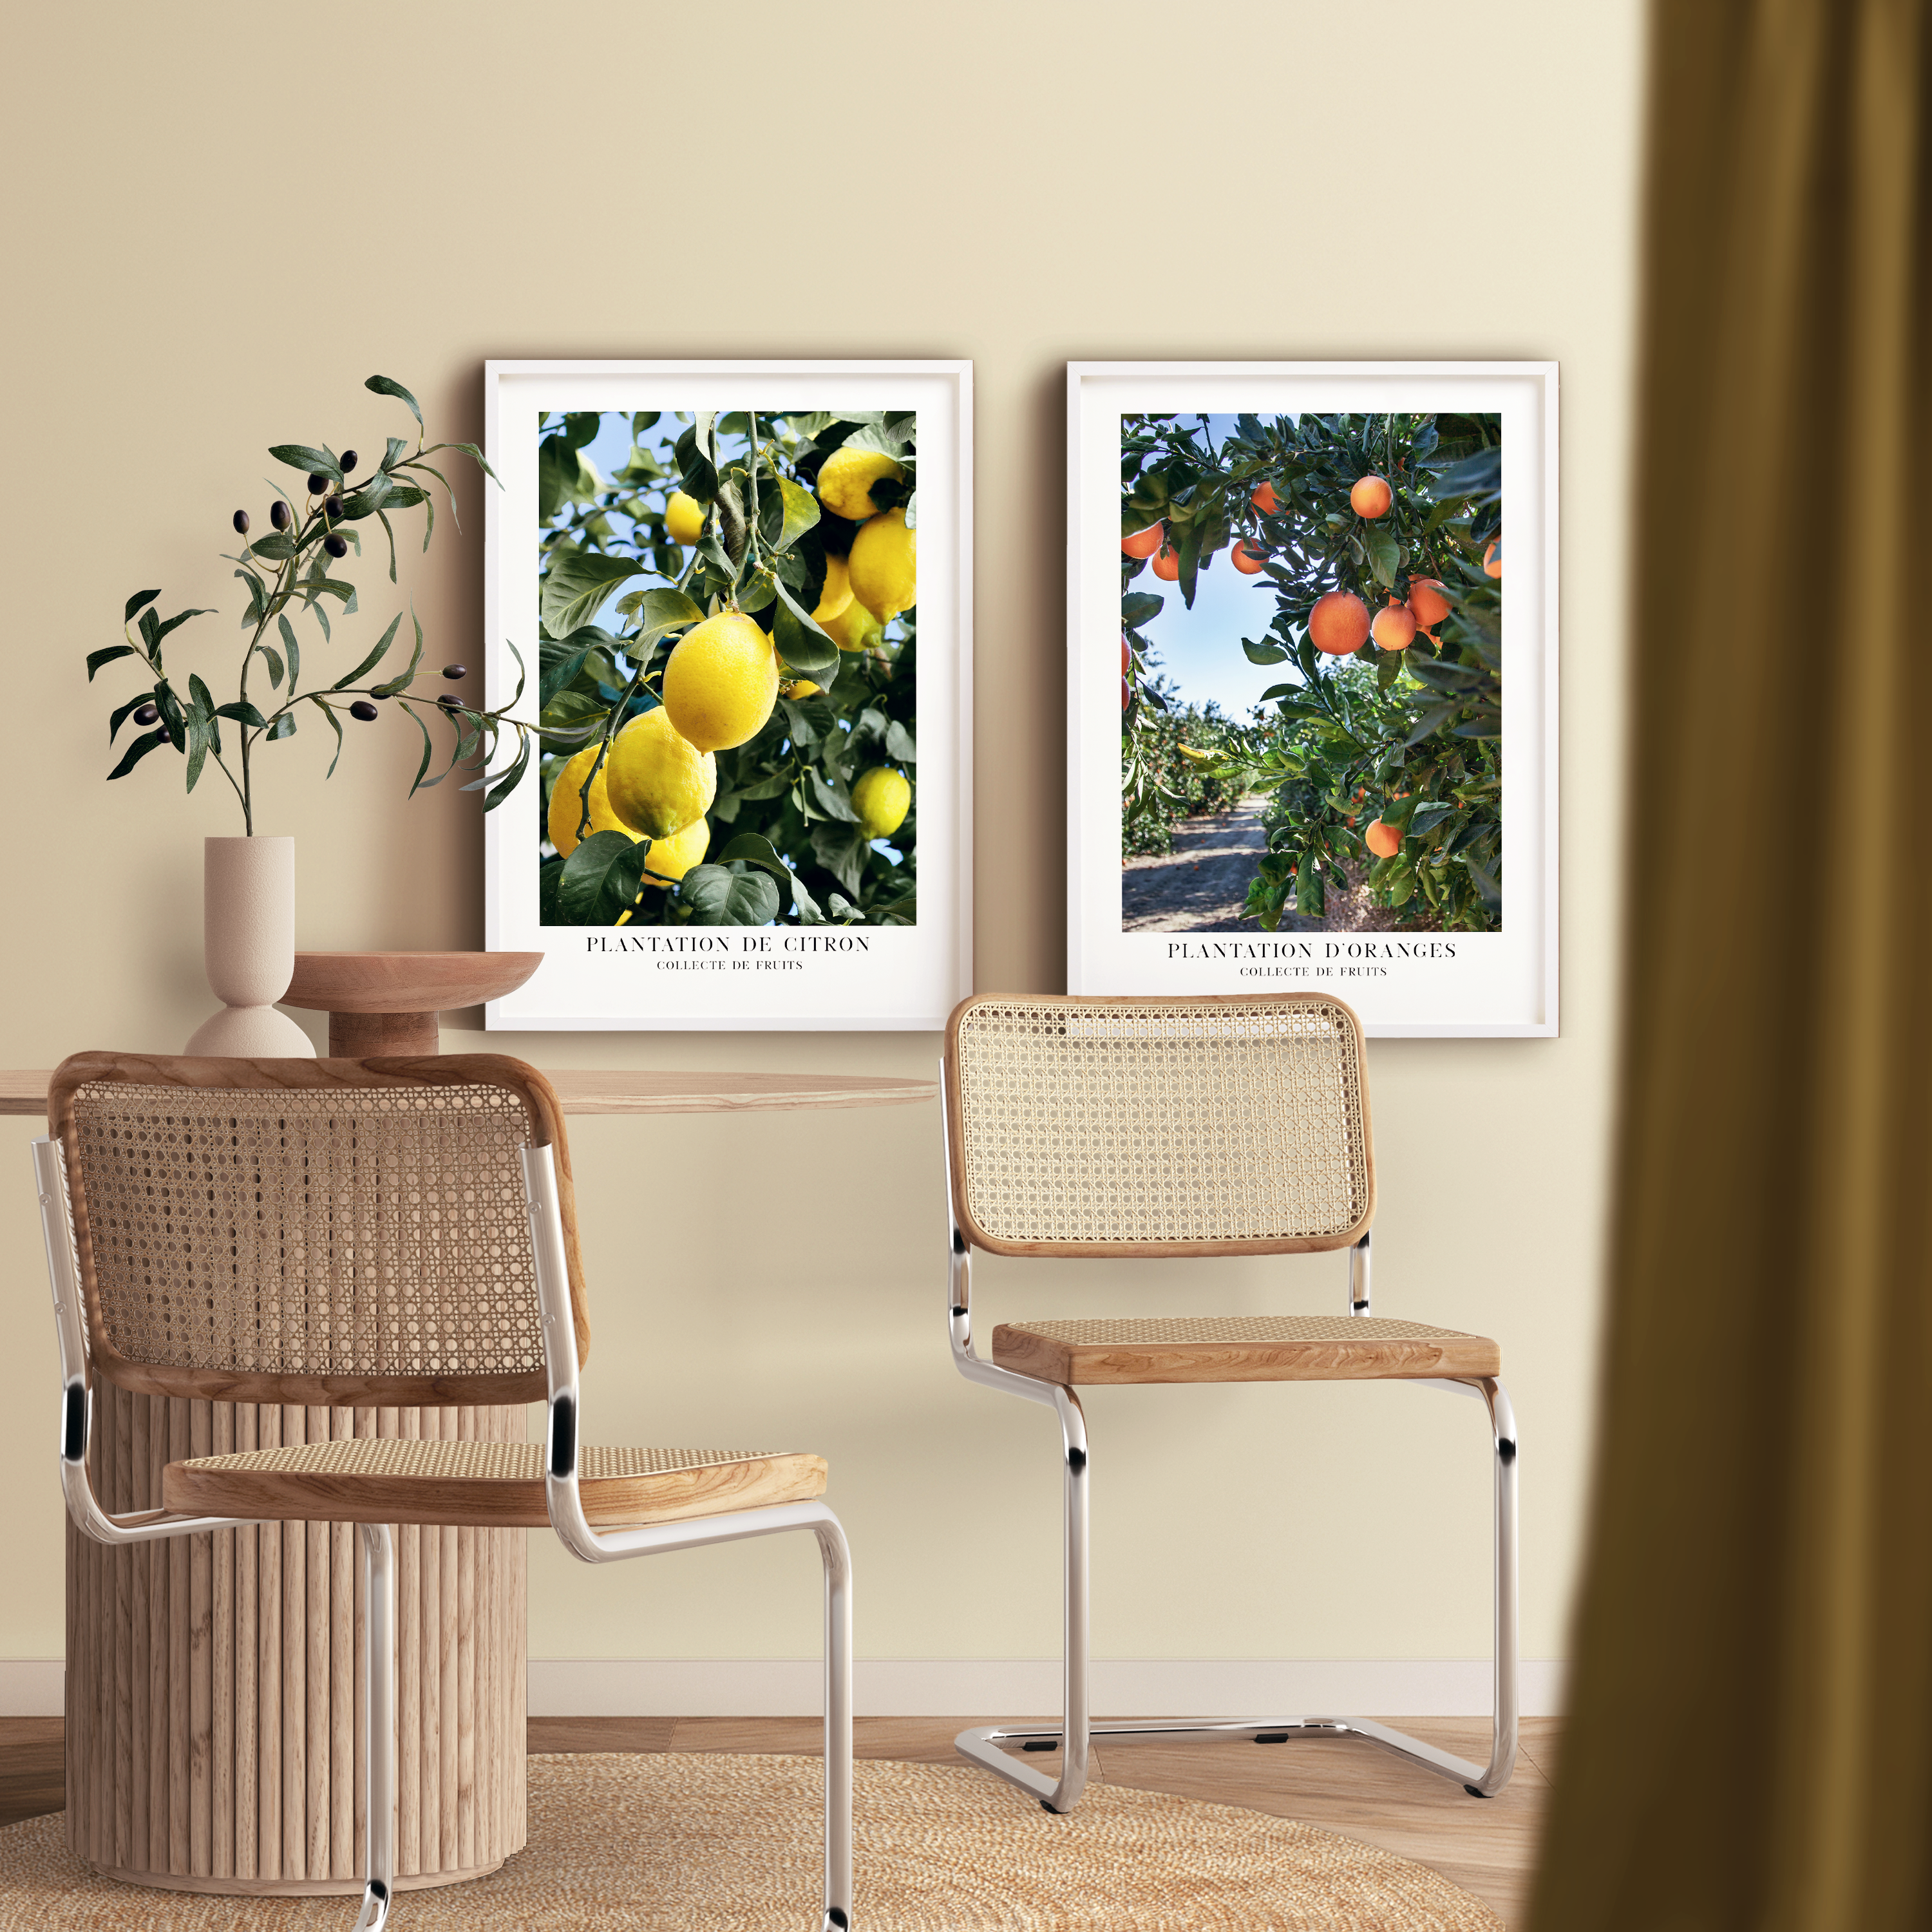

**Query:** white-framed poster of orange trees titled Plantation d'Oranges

left=1066, top=363, right=1557, bottom=1036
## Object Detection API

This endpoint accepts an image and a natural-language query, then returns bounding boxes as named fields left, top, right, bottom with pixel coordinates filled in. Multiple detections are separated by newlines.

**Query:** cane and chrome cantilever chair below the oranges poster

left=941, top=993, right=1517, bottom=1812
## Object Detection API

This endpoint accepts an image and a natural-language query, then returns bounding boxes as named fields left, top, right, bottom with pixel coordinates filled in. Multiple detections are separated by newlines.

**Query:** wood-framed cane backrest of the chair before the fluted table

left=48, top=1053, right=589, bottom=1406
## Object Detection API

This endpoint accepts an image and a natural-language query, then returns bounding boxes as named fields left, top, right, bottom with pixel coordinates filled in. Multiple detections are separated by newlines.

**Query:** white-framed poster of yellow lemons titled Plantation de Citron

left=485, top=361, right=972, bottom=1030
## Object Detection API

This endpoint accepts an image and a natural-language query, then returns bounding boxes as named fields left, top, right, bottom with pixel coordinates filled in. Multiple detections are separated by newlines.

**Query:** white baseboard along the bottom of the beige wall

left=0, top=1658, right=1563, bottom=1719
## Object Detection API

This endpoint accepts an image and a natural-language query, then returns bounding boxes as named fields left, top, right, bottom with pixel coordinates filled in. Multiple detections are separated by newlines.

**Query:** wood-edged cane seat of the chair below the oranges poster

left=993, top=1316, right=1503, bottom=1385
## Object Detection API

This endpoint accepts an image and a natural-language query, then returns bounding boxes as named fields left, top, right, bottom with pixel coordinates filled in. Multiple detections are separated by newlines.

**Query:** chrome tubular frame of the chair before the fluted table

left=33, top=1136, right=852, bottom=1932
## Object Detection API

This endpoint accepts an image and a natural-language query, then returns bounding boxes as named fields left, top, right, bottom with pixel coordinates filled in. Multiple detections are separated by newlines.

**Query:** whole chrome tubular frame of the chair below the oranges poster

left=939, top=1061, right=1517, bottom=1812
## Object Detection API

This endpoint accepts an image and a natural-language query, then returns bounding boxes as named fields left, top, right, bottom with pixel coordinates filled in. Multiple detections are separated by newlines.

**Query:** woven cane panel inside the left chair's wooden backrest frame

left=70, top=1080, right=543, bottom=1383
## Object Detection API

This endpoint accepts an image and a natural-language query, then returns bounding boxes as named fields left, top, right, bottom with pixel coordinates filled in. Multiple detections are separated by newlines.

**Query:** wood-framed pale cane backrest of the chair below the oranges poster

left=956, top=999, right=1370, bottom=1244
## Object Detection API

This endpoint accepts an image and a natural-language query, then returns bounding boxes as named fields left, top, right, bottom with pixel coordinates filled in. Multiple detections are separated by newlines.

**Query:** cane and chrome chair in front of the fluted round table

left=33, top=1053, right=852, bottom=1932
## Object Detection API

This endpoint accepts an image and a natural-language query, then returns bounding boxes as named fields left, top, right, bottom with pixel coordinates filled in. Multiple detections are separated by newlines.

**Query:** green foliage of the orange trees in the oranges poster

left=1121, top=415, right=1503, bottom=931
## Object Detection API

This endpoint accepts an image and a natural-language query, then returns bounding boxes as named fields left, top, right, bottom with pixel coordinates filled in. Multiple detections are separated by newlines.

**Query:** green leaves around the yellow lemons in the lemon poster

left=537, top=410, right=918, bottom=925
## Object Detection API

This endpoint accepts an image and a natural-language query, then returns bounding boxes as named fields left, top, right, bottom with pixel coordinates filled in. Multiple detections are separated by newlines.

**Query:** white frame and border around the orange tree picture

left=1066, top=361, right=1557, bottom=1037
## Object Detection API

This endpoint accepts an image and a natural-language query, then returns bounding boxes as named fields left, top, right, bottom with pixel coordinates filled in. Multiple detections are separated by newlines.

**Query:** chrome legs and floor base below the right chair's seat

left=952, top=1378, right=1517, bottom=1812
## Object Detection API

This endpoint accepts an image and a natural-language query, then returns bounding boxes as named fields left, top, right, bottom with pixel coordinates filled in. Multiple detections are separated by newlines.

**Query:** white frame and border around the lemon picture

left=483, top=361, right=972, bottom=1032
